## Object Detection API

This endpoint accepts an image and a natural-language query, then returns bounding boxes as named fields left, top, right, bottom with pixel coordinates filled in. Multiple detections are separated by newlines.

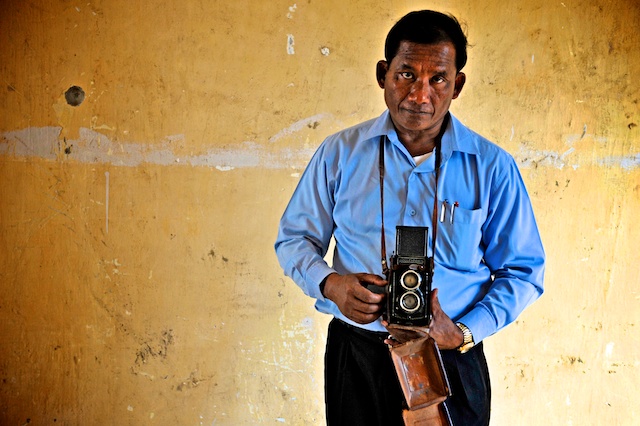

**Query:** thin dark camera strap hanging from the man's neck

left=379, top=113, right=449, bottom=278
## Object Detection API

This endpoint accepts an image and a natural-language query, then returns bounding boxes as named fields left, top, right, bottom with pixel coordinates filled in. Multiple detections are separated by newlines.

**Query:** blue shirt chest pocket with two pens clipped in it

left=436, top=207, right=486, bottom=272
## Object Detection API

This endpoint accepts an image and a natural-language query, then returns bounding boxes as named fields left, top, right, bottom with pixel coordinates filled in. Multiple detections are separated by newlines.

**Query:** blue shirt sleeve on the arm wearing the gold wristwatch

left=458, top=158, right=545, bottom=343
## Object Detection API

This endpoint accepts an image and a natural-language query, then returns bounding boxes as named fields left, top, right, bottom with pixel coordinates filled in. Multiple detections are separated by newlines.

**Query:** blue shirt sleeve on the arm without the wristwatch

left=275, top=141, right=335, bottom=300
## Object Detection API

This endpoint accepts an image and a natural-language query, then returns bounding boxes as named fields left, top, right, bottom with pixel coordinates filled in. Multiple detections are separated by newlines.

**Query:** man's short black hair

left=384, top=10, right=467, bottom=71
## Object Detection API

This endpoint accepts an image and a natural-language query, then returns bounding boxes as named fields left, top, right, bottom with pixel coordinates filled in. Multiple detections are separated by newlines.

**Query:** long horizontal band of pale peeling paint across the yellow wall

left=0, top=126, right=640, bottom=171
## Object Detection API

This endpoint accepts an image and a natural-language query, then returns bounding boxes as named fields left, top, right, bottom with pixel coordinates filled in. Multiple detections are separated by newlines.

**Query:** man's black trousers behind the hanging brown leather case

left=325, top=319, right=491, bottom=426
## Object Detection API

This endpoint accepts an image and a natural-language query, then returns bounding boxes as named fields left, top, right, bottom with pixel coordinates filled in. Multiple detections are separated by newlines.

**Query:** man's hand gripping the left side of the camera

left=324, top=273, right=387, bottom=324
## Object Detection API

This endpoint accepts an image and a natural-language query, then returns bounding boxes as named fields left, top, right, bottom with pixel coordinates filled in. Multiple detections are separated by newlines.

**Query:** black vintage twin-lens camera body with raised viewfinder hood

left=385, top=226, right=433, bottom=326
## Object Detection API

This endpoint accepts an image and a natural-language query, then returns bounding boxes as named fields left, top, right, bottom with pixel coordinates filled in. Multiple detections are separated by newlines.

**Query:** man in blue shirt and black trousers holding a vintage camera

left=275, top=11, right=544, bottom=426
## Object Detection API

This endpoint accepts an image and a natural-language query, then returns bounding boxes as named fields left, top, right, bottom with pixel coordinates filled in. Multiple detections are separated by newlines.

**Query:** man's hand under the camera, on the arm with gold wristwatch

left=382, top=289, right=464, bottom=349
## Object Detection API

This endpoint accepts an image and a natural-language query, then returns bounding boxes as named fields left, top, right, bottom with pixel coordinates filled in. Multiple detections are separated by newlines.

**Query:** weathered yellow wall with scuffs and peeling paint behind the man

left=0, top=0, right=640, bottom=425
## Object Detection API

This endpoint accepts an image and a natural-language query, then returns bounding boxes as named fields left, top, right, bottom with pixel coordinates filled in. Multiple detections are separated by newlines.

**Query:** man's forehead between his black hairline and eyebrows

left=391, top=41, right=456, bottom=71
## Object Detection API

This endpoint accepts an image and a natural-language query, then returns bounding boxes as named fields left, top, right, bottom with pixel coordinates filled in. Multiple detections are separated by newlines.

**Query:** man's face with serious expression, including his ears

left=377, top=41, right=465, bottom=142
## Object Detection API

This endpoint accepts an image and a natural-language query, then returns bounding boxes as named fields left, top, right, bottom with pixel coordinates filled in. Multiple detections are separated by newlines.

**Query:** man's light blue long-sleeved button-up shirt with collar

left=275, top=111, right=545, bottom=343
